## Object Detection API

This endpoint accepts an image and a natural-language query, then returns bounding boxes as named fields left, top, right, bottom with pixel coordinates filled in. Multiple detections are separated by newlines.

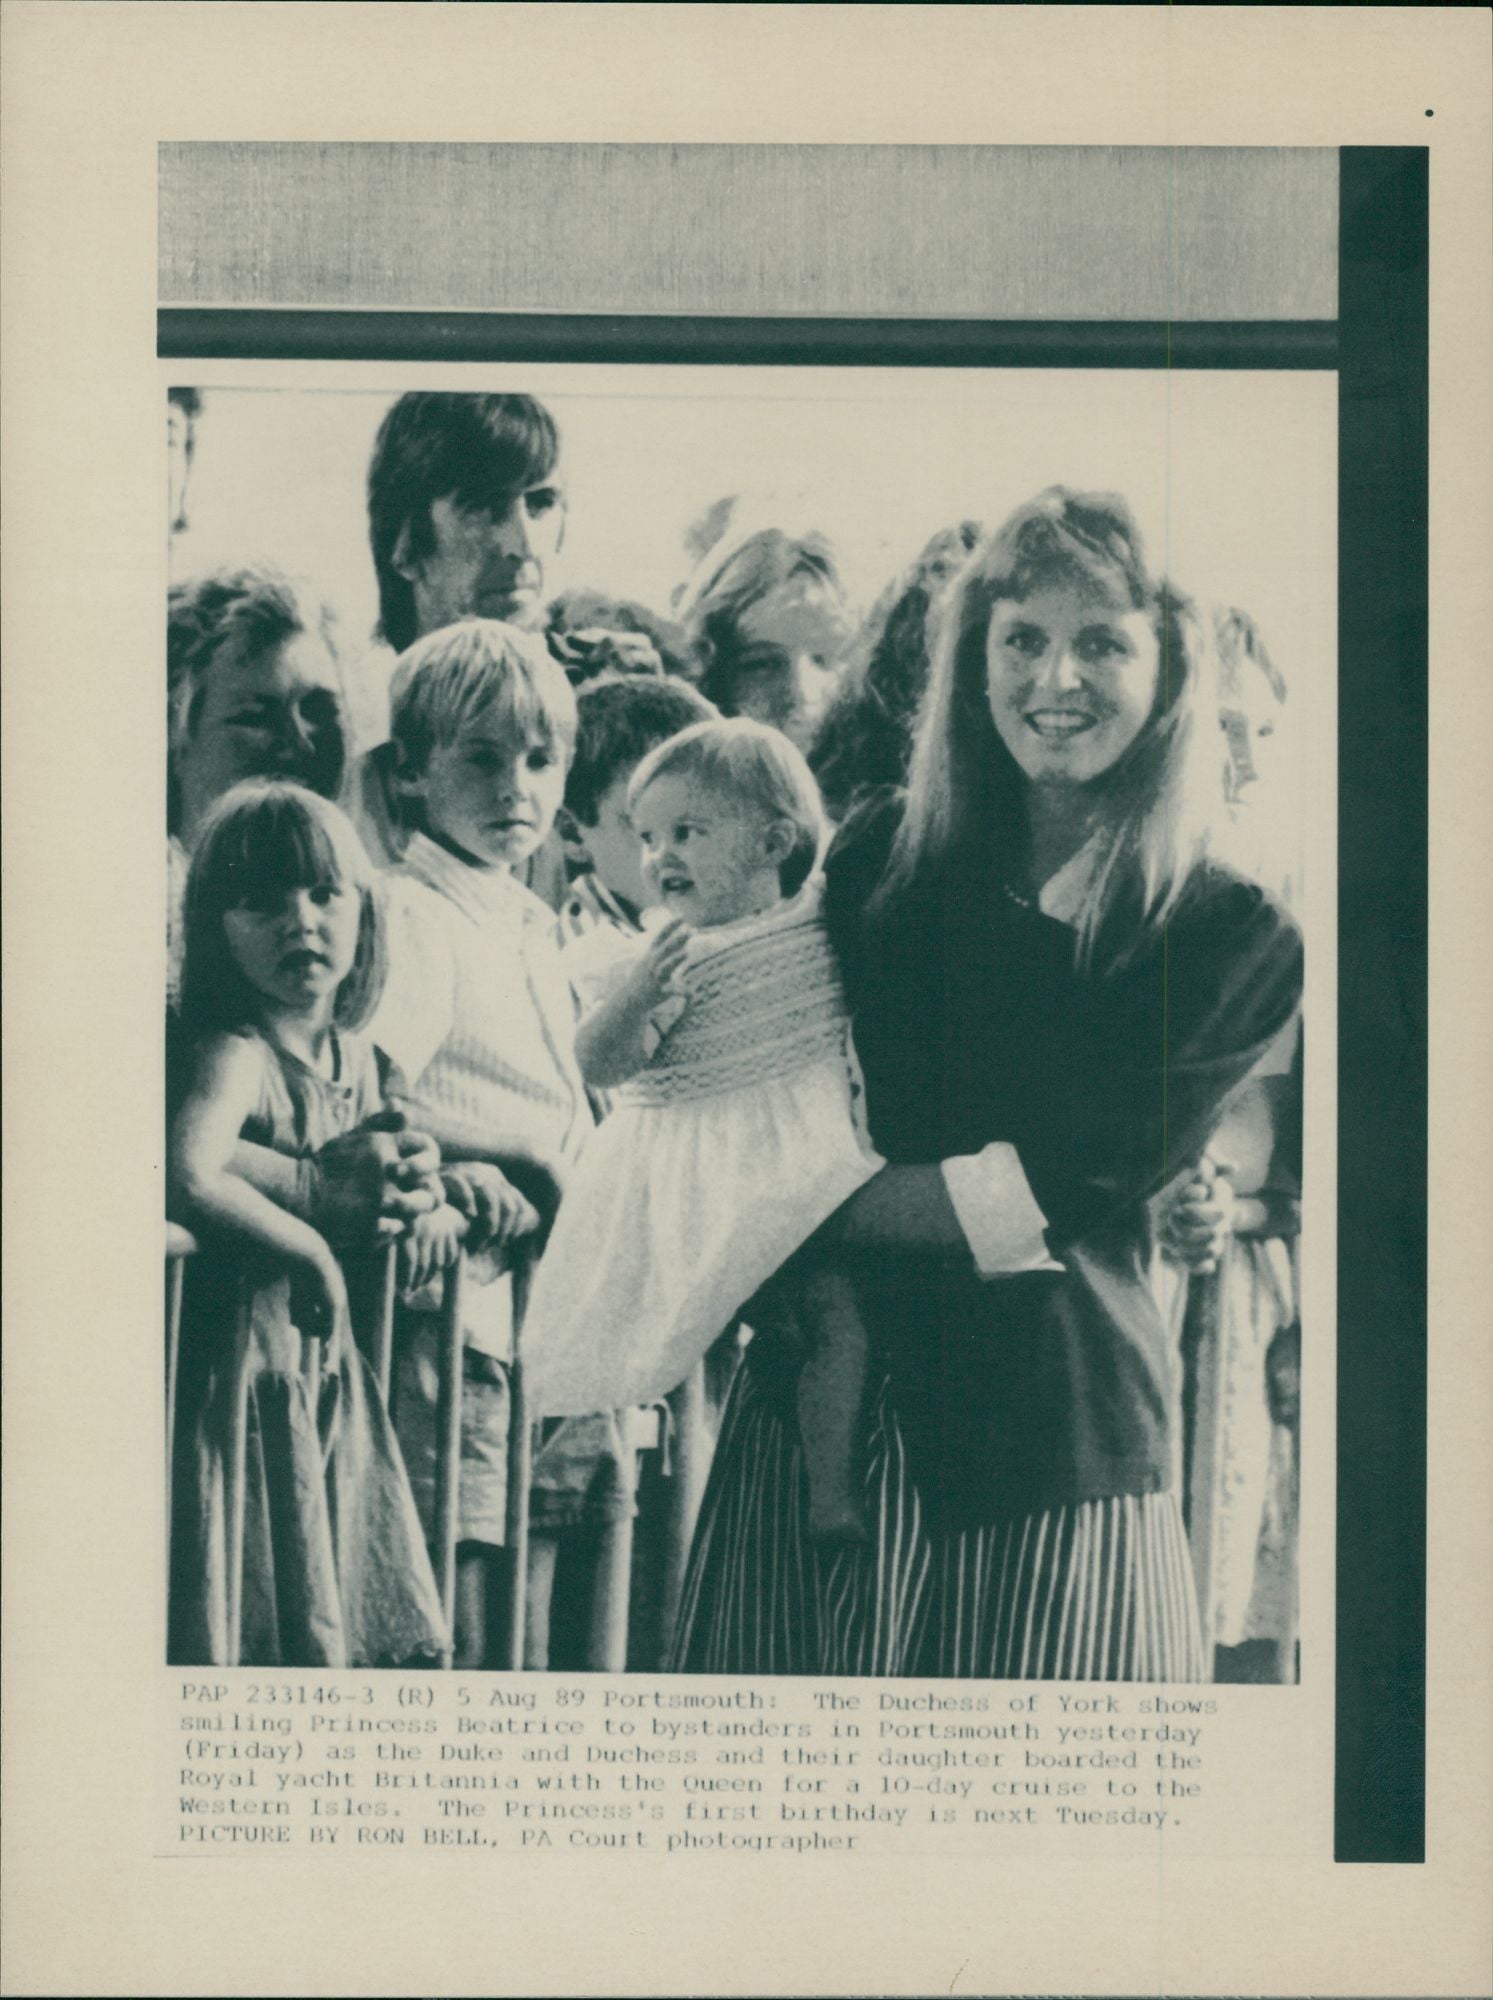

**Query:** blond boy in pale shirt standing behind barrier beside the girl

left=372, top=618, right=590, bottom=1666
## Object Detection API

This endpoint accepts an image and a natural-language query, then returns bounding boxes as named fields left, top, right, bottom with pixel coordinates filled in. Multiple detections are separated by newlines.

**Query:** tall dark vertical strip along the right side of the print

left=1333, top=146, right=1429, bottom=1862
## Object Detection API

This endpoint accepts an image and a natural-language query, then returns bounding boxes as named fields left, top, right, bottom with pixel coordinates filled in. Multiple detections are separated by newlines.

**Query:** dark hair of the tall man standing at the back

left=368, top=390, right=560, bottom=652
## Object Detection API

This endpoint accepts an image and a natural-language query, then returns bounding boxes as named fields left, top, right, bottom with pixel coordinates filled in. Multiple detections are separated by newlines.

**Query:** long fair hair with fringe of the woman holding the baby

left=873, top=486, right=1221, bottom=966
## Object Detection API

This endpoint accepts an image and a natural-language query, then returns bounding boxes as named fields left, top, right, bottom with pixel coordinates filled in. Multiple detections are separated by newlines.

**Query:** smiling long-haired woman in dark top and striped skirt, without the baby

left=674, top=488, right=1301, bottom=1680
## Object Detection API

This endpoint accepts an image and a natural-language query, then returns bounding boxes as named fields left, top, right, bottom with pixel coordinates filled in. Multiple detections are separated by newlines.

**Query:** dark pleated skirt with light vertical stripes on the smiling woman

left=670, top=1360, right=1207, bottom=1682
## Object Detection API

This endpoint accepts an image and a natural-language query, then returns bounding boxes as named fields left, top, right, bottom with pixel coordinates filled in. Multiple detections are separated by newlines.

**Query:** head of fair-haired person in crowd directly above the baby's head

left=674, top=508, right=855, bottom=756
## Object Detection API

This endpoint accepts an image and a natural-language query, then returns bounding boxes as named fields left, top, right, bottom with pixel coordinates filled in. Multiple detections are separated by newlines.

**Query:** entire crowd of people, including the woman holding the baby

left=168, top=390, right=1301, bottom=1680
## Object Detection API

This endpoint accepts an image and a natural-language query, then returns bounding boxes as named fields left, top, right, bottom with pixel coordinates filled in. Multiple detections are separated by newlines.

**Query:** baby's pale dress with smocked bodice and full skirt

left=524, top=884, right=881, bottom=1416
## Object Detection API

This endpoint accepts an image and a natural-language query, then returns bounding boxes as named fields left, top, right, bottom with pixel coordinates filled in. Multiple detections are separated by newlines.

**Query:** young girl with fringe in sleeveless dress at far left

left=170, top=782, right=446, bottom=1666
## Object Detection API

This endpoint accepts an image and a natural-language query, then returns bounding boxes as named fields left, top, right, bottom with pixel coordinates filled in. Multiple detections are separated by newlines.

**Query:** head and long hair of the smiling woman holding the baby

left=881, top=486, right=1223, bottom=956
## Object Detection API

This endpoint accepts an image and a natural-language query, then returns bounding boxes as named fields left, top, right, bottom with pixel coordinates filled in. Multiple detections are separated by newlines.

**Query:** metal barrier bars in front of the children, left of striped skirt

left=166, top=1224, right=712, bottom=1672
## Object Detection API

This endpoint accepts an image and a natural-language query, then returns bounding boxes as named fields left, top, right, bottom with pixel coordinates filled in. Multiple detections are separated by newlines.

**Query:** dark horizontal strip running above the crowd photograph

left=156, top=306, right=1337, bottom=368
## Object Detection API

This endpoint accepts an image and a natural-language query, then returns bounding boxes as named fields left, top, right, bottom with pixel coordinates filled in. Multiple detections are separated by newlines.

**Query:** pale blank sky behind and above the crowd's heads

left=172, top=368, right=1337, bottom=884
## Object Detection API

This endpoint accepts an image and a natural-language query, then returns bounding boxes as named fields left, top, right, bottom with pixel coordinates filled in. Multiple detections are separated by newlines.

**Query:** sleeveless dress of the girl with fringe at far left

left=170, top=1036, right=446, bottom=1666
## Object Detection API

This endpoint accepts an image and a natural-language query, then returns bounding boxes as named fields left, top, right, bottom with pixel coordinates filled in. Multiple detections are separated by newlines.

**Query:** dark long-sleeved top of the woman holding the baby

left=808, top=798, right=1301, bottom=1526
